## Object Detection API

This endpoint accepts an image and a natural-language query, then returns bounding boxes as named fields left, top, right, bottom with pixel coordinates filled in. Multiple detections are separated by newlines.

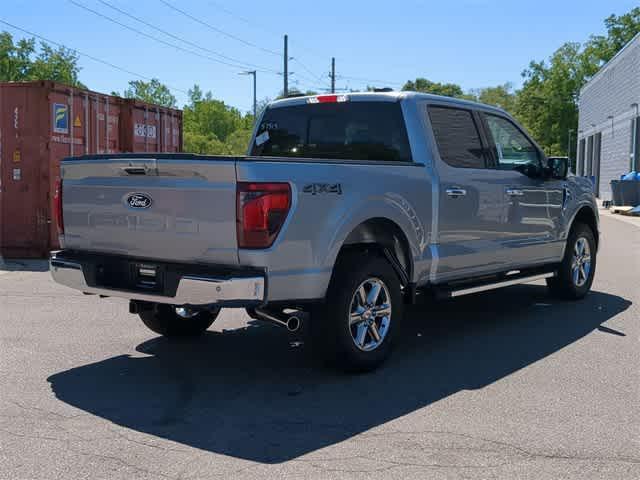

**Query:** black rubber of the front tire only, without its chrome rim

left=547, top=223, right=597, bottom=300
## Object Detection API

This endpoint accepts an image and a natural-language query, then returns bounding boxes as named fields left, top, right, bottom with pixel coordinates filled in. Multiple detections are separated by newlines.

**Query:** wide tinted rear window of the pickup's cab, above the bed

left=251, top=101, right=412, bottom=162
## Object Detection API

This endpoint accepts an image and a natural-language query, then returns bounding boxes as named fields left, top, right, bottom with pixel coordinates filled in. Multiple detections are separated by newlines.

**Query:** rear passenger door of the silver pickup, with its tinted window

left=427, top=104, right=505, bottom=283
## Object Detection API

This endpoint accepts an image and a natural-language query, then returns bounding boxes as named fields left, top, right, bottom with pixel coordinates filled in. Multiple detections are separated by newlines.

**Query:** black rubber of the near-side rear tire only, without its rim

left=311, top=252, right=404, bottom=372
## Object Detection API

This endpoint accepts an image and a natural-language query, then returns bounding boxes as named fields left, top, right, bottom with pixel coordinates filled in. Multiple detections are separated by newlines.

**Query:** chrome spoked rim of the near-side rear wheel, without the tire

left=349, top=278, right=391, bottom=352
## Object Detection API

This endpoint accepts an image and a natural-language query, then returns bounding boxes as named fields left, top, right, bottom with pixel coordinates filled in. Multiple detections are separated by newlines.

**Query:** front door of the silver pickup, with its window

left=481, top=113, right=563, bottom=266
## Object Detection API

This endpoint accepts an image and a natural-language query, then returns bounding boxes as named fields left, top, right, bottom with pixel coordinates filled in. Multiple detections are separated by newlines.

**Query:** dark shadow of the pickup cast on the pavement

left=48, top=285, right=631, bottom=463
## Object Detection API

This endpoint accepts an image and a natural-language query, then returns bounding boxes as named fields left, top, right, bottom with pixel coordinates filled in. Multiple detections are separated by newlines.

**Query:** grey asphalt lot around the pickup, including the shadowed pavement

left=0, top=216, right=640, bottom=480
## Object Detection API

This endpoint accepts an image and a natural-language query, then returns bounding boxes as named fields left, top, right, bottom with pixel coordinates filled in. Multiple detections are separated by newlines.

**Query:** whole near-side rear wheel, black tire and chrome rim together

left=311, top=253, right=403, bottom=372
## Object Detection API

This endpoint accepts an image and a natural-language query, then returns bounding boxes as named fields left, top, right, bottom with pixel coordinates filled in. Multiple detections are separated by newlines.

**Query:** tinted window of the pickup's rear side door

left=429, top=106, right=486, bottom=168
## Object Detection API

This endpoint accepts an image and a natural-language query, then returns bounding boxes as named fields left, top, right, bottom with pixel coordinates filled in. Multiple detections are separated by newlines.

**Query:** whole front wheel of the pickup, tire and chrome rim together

left=547, top=223, right=596, bottom=300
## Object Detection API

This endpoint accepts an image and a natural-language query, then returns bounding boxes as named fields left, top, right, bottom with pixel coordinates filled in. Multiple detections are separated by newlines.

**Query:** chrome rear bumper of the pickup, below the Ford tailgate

left=49, top=251, right=266, bottom=307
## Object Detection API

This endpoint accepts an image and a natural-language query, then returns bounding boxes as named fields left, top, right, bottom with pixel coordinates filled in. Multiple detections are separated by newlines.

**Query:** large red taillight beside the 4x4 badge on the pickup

left=236, top=183, right=291, bottom=248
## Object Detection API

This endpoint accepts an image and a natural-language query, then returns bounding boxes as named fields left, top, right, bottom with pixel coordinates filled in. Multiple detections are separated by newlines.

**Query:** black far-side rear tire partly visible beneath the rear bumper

left=139, top=304, right=220, bottom=337
